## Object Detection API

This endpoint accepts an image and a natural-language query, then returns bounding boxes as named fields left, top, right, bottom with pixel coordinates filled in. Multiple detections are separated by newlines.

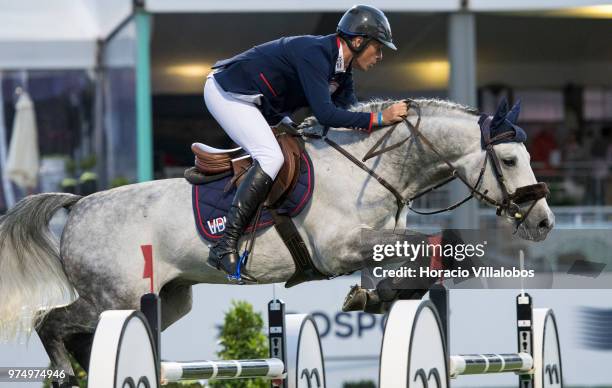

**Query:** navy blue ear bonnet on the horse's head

left=478, top=99, right=527, bottom=149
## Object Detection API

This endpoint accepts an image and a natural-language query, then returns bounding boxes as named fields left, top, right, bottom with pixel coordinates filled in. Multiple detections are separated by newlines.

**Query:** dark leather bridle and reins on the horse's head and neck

left=303, top=99, right=550, bottom=233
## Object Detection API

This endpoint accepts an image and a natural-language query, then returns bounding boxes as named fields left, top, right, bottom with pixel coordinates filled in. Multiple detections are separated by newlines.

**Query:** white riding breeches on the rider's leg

left=204, top=75, right=284, bottom=179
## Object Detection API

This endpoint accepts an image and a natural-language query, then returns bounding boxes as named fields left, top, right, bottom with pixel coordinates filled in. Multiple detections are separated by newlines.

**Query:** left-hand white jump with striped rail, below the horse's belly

left=88, top=294, right=325, bottom=388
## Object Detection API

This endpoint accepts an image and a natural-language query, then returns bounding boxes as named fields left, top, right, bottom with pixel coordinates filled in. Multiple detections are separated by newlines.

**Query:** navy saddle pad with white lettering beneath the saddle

left=192, top=152, right=314, bottom=242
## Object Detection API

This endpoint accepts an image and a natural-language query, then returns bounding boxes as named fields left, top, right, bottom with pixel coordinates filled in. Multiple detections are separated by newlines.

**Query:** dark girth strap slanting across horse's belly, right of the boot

left=268, top=209, right=331, bottom=288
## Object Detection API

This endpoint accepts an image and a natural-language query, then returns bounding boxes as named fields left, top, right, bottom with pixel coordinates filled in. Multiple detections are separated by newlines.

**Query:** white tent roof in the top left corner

left=0, top=0, right=132, bottom=70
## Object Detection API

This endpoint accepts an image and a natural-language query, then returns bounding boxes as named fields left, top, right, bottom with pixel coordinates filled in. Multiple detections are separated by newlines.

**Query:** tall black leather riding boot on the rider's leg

left=208, top=161, right=273, bottom=282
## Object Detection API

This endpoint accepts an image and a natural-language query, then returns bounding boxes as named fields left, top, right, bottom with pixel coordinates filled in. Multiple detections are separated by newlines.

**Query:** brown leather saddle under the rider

left=185, top=130, right=304, bottom=207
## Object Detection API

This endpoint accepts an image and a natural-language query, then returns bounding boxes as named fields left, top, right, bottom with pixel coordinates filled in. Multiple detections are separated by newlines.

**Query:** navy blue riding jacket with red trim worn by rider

left=213, top=35, right=373, bottom=130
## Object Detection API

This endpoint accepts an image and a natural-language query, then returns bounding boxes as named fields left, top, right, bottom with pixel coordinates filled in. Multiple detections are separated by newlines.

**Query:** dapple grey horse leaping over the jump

left=0, top=100, right=554, bottom=384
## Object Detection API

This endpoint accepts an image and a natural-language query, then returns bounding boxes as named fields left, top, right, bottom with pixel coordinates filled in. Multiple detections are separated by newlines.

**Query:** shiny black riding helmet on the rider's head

left=336, top=5, right=397, bottom=51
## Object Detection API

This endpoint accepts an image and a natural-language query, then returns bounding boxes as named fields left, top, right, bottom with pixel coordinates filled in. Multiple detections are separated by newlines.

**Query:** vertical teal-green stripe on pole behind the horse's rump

left=135, top=11, right=153, bottom=182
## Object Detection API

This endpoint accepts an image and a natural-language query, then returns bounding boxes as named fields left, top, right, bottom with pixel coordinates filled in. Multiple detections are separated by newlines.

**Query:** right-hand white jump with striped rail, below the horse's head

left=379, top=289, right=563, bottom=388
